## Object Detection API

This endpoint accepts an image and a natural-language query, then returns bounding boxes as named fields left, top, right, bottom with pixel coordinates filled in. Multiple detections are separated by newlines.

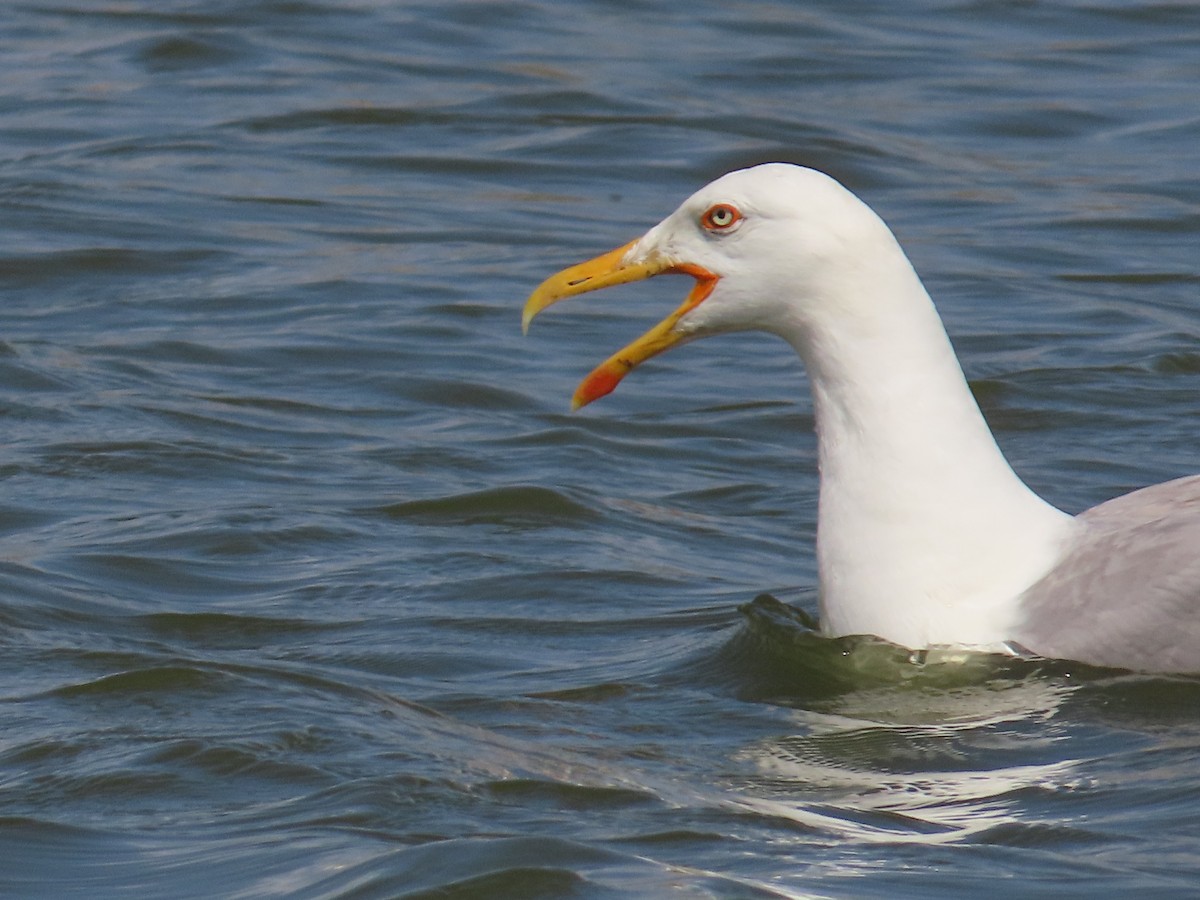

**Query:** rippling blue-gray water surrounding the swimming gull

left=0, top=0, right=1200, bottom=900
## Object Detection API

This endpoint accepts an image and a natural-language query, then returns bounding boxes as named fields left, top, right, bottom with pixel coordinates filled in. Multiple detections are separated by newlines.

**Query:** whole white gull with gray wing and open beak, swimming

left=526, top=163, right=1200, bottom=672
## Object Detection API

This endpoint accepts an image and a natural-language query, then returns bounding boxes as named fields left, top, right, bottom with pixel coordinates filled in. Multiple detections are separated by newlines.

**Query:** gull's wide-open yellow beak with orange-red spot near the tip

left=521, top=240, right=720, bottom=410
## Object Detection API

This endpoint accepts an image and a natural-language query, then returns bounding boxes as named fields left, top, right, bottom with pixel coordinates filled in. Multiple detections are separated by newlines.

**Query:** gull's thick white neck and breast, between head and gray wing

left=780, top=233, right=1073, bottom=649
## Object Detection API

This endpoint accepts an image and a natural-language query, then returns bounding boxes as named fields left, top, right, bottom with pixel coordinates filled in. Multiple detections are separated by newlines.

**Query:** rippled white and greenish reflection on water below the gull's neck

left=720, top=598, right=1081, bottom=844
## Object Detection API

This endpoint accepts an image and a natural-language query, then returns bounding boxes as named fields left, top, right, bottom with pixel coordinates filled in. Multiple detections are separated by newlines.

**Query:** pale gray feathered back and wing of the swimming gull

left=1014, top=475, right=1200, bottom=672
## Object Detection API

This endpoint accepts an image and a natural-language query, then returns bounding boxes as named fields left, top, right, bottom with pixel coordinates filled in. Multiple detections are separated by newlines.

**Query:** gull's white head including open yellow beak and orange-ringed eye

left=524, top=163, right=911, bottom=407
